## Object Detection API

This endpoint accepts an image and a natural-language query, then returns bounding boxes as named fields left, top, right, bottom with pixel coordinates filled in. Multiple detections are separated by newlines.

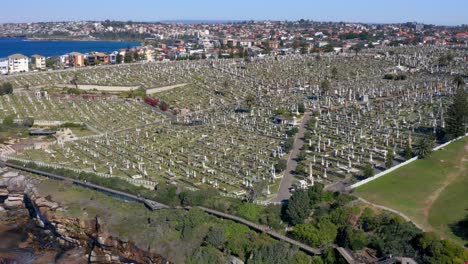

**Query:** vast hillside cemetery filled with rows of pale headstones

left=0, top=47, right=467, bottom=201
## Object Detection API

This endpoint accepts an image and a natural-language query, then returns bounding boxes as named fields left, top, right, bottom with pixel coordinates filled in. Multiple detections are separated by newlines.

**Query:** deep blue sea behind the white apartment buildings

left=0, top=38, right=140, bottom=58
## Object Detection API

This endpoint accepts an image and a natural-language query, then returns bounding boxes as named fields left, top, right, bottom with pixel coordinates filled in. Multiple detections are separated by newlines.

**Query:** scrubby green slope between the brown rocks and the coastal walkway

left=34, top=176, right=311, bottom=264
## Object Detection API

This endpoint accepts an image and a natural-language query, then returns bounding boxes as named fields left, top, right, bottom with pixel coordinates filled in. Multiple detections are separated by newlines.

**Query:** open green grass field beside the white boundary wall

left=355, top=138, right=468, bottom=244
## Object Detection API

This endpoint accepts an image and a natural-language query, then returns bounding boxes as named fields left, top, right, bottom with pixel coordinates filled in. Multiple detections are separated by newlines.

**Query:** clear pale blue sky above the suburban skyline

left=0, top=0, right=468, bottom=25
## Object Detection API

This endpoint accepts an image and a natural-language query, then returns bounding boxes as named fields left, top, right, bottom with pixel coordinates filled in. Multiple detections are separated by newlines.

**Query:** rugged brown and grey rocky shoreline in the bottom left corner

left=0, top=168, right=170, bottom=263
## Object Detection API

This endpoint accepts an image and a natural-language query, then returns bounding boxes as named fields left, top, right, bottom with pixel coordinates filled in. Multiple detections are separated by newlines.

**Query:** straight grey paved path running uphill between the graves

left=270, top=112, right=311, bottom=203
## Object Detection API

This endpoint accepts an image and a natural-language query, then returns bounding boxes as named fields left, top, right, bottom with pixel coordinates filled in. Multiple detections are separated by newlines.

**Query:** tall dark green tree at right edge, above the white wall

left=446, top=82, right=468, bottom=138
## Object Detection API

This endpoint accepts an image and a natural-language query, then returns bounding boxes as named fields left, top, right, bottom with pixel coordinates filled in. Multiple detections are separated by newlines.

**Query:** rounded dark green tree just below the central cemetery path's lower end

left=286, top=190, right=310, bottom=225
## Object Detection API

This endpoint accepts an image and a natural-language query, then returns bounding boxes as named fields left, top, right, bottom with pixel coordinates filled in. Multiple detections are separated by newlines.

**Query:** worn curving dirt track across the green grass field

left=422, top=143, right=468, bottom=231
